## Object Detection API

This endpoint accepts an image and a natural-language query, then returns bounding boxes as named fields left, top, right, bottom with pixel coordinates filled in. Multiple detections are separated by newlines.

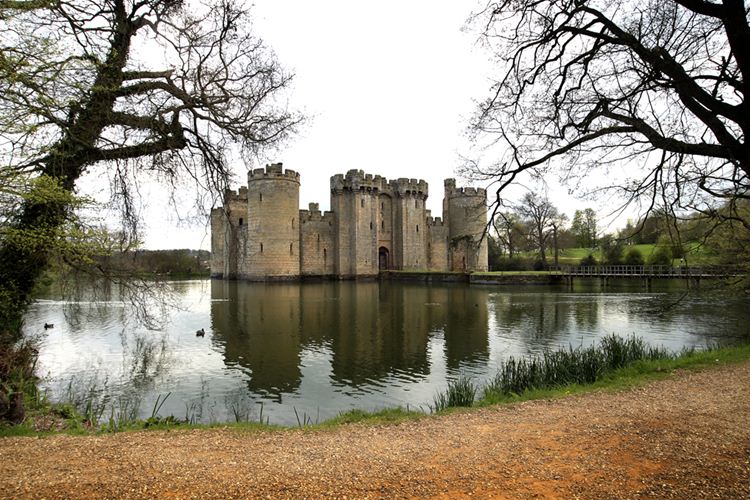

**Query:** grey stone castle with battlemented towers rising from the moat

left=211, top=163, right=487, bottom=281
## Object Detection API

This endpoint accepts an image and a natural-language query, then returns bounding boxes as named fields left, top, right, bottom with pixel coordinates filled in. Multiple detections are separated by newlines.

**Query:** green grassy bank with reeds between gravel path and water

left=0, top=337, right=750, bottom=436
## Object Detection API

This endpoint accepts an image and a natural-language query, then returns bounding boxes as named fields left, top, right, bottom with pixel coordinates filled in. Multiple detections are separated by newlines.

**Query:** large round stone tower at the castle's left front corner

left=241, top=163, right=300, bottom=280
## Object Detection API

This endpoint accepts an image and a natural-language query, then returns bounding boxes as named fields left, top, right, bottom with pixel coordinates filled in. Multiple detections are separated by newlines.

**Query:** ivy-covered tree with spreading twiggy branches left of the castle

left=0, top=0, right=300, bottom=328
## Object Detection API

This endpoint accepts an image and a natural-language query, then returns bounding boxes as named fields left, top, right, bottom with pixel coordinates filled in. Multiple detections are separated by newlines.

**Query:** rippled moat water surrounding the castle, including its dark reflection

left=26, top=280, right=750, bottom=425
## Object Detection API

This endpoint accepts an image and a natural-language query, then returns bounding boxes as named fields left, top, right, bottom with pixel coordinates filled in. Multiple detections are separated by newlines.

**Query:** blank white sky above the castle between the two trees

left=123, top=0, right=624, bottom=249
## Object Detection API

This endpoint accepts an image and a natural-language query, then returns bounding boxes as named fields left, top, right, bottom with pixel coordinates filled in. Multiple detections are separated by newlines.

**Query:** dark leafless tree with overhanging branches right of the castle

left=466, top=0, right=750, bottom=232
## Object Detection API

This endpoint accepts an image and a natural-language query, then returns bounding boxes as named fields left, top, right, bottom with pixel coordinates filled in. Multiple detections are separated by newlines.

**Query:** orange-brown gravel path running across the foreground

left=0, top=363, right=750, bottom=498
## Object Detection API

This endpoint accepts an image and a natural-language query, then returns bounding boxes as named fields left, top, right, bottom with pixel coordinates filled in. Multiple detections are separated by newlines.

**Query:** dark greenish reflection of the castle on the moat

left=211, top=280, right=488, bottom=395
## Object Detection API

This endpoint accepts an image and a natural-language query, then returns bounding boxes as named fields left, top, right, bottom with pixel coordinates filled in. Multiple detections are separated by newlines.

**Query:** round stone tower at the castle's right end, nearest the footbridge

left=450, top=179, right=487, bottom=272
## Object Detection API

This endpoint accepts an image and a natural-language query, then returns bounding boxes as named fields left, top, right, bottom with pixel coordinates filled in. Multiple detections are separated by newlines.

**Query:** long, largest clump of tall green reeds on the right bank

left=483, top=335, right=677, bottom=399
